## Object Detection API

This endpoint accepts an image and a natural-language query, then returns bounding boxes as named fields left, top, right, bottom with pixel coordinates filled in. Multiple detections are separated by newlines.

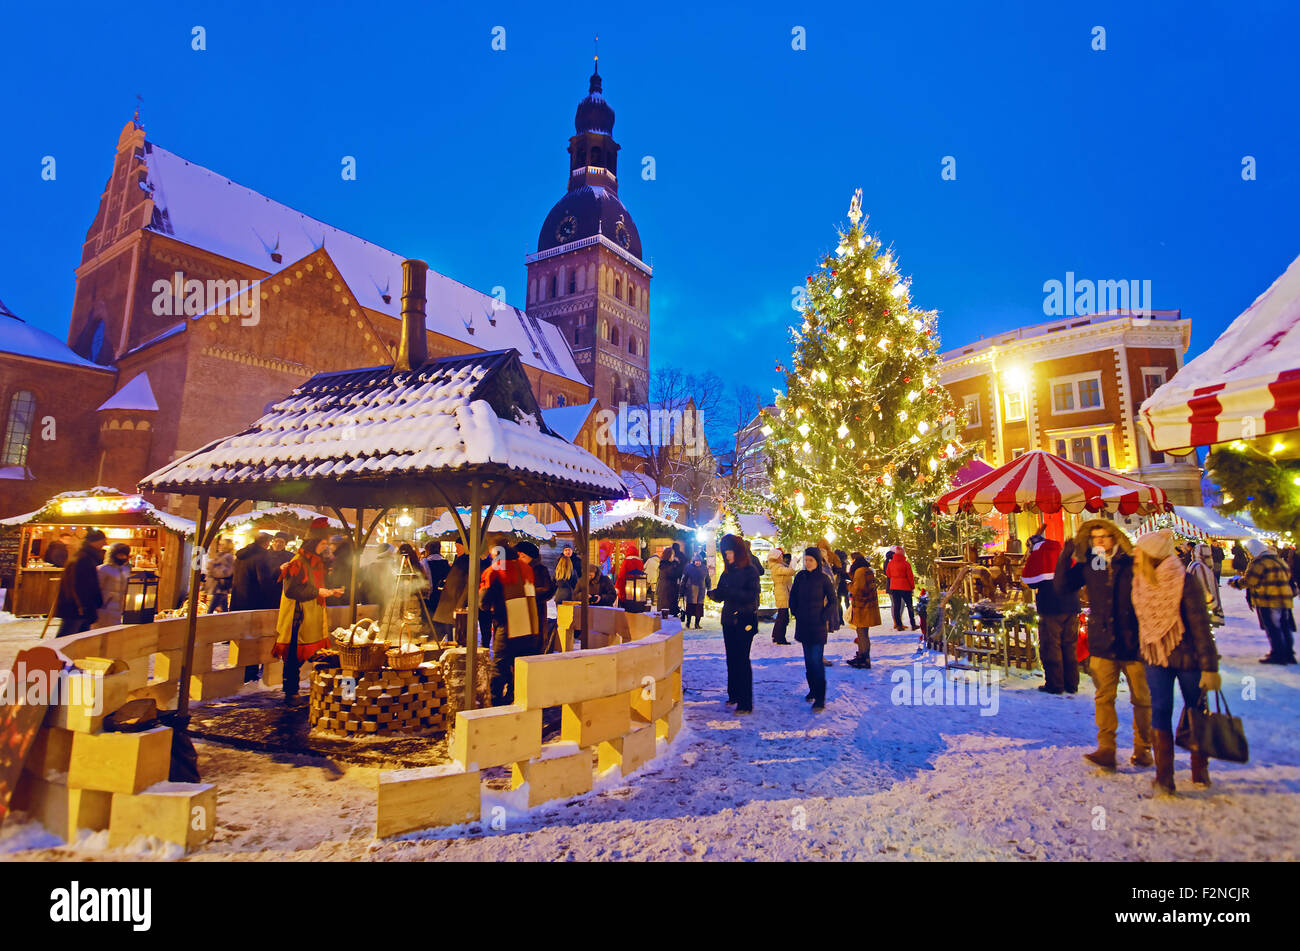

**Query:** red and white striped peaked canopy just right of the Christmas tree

left=935, top=450, right=1170, bottom=514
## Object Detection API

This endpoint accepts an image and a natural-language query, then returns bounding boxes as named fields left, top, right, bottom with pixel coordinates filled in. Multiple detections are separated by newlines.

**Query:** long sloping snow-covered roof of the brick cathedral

left=146, top=143, right=586, bottom=385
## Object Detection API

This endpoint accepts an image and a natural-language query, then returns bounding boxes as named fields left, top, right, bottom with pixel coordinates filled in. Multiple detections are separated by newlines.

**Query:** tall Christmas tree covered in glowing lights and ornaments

left=764, top=190, right=974, bottom=569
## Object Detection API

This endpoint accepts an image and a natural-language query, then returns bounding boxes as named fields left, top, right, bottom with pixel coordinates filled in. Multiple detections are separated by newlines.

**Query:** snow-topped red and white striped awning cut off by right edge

left=1140, top=257, right=1300, bottom=452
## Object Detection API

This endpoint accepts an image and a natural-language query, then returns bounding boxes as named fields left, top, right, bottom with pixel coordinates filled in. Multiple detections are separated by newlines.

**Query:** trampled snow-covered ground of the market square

left=0, top=587, right=1300, bottom=861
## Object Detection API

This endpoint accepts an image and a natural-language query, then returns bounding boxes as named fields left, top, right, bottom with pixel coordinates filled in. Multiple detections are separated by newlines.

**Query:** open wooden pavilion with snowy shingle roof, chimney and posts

left=140, top=261, right=627, bottom=716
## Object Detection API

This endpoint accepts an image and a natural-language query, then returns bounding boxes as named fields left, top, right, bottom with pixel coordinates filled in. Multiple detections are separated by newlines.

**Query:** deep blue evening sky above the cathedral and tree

left=0, top=0, right=1300, bottom=395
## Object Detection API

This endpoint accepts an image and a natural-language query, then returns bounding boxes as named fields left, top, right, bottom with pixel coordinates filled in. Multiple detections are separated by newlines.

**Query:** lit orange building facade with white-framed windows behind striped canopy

left=940, top=311, right=1201, bottom=505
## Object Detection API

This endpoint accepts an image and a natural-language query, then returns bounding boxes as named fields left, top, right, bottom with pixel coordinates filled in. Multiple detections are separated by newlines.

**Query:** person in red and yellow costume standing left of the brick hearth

left=270, top=517, right=343, bottom=700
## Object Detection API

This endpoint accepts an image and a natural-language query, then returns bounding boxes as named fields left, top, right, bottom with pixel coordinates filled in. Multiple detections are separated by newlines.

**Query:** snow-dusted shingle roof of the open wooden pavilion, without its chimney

left=140, top=351, right=627, bottom=498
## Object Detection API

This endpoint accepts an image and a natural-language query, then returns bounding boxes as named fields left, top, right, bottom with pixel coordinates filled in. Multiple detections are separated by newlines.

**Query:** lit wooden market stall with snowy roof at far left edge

left=0, top=486, right=194, bottom=617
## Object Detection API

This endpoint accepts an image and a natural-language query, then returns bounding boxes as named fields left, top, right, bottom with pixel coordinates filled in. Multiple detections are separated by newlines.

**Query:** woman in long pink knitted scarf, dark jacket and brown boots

left=1132, top=530, right=1222, bottom=795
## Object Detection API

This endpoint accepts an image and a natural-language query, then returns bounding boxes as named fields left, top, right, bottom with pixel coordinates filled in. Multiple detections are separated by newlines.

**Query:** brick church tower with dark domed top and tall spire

left=525, top=62, right=650, bottom=408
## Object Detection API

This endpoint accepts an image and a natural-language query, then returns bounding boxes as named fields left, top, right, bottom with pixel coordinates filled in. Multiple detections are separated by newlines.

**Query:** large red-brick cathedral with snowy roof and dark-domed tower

left=0, top=66, right=650, bottom=517
